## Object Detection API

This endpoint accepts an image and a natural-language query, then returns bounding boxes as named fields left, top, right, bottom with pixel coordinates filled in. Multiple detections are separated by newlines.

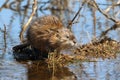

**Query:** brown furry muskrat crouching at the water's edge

left=13, top=15, right=76, bottom=57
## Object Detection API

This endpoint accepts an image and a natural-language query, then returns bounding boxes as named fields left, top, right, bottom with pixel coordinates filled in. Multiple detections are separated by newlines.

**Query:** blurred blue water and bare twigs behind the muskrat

left=0, top=0, right=120, bottom=53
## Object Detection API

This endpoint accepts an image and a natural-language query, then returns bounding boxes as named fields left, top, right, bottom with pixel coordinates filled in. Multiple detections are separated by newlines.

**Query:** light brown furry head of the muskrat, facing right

left=49, top=28, right=76, bottom=49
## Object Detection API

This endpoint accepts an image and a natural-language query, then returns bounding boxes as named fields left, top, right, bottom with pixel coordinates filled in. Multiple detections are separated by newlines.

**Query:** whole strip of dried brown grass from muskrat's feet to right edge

left=47, top=40, right=120, bottom=64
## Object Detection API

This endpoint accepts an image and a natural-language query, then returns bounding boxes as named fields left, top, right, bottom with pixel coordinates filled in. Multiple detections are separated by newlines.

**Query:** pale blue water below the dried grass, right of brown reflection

left=69, top=55, right=120, bottom=80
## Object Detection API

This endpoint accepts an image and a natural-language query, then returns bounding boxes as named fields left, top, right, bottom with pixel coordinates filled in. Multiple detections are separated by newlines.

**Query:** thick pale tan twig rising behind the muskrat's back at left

left=20, top=0, right=37, bottom=42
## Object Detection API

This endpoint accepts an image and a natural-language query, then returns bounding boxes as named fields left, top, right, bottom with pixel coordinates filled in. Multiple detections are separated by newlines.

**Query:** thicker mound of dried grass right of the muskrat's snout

left=74, top=40, right=120, bottom=59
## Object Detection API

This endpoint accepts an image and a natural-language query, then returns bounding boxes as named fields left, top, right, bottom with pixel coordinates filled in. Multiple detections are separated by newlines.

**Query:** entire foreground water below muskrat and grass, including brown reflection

left=0, top=54, right=120, bottom=80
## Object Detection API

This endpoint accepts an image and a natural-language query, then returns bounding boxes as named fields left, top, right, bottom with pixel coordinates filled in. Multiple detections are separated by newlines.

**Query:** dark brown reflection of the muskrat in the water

left=20, top=61, right=77, bottom=80
